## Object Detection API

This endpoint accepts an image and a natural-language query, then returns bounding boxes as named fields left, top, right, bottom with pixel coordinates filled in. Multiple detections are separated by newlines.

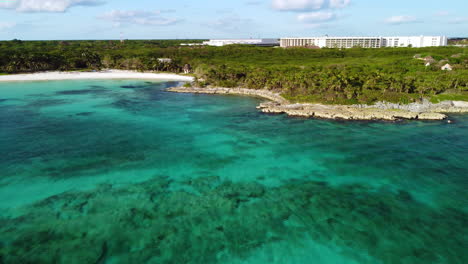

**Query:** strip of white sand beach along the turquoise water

left=0, top=70, right=193, bottom=82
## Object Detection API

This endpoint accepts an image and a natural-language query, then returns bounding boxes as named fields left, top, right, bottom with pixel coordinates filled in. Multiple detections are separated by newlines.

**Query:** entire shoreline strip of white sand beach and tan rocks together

left=0, top=70, right=468, bottom=121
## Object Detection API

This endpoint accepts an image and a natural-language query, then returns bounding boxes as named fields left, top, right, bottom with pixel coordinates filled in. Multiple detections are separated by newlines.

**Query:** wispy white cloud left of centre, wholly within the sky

left=99, top=10, right=181, bottom=26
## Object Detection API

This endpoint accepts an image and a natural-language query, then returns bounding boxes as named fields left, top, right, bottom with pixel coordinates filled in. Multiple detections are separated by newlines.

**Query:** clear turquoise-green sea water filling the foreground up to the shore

left=0, top=80, right=468, bottom=264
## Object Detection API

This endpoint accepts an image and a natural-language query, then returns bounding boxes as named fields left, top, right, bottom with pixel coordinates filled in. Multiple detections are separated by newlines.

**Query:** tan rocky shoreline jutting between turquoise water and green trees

left=168, top=87, right=468, bottom=121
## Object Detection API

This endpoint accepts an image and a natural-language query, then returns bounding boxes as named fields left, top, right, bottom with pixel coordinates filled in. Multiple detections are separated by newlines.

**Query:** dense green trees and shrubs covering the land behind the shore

left=0, top=40, right=468, bottom=104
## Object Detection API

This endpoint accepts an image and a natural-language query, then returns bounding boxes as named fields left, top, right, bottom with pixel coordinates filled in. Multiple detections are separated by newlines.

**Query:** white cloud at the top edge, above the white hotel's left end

left=272, top=0, right=351, bottom=12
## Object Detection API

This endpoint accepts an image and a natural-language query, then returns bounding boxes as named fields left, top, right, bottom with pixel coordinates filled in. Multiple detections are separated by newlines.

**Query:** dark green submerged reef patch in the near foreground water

left=0, top=176, right=468, bottom=264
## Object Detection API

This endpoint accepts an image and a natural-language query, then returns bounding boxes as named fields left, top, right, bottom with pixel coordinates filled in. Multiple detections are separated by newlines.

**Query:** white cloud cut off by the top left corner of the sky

left=0, top=0, right=104, bottom=12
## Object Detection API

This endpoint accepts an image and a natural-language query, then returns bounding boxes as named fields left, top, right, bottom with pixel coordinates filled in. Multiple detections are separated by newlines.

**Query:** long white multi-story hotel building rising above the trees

left=280, top=36, right=447, bottom=48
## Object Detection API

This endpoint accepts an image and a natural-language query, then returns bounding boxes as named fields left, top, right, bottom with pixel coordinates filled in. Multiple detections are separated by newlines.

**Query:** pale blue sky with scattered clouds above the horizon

left=0, top=0, right=468, bottom=40
